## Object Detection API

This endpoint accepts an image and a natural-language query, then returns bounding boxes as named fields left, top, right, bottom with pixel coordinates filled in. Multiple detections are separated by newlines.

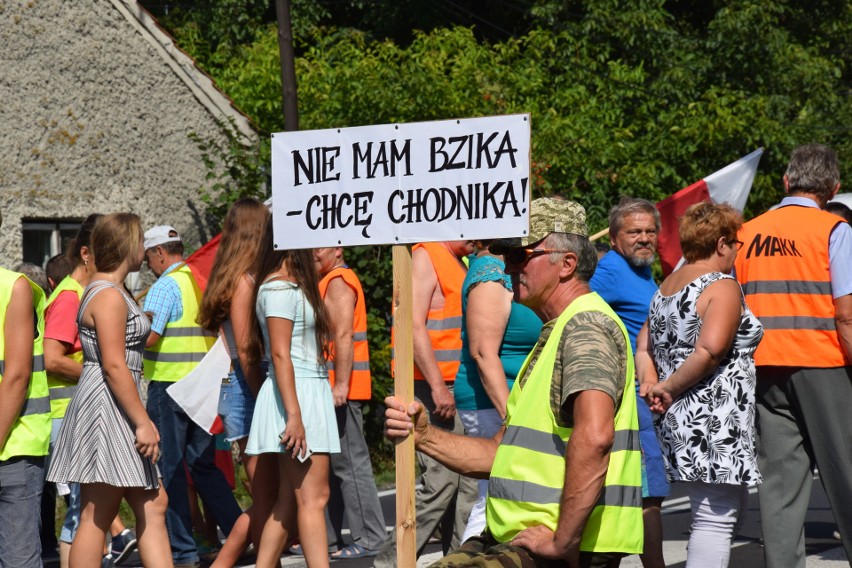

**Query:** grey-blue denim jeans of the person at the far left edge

left=0, top=456, right=44, bottom=568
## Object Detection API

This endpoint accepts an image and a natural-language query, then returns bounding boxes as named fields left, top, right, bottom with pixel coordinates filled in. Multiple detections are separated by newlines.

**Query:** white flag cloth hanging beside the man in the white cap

left=166, top=336, right=231, bottom=432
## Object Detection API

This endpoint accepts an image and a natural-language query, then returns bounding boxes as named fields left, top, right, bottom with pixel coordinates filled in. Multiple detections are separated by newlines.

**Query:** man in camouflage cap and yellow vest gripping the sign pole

left=386, top=199, right=643, bottom=567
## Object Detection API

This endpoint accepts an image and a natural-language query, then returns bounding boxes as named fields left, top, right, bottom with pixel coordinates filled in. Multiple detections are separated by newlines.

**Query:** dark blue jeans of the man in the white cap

left=148, top=381, right=242, bottom=564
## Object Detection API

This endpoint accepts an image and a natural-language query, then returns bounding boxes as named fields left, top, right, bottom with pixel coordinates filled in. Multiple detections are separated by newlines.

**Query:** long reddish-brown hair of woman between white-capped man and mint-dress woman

left=197, top=197, right=270, bottom=331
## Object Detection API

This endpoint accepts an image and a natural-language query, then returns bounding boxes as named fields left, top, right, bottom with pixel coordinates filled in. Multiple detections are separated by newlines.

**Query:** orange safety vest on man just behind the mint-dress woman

left=320, top=266, right=373, bottom=400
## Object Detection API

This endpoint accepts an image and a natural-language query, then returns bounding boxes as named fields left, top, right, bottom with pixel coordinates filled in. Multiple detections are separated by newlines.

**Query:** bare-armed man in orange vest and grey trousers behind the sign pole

left=374, top=241, right=477, bottom=568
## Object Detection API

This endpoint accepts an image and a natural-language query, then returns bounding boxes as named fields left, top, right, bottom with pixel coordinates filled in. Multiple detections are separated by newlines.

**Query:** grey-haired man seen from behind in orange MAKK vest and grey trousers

left=734, top=144, right=852, bottom=568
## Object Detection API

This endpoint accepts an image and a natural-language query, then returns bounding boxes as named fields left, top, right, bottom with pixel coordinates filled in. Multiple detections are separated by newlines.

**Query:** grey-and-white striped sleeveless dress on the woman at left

left=47, top=281, right=160, bottom=489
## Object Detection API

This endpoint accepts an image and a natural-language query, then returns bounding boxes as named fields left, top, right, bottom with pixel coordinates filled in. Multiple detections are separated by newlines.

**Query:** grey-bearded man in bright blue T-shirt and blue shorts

left=589, top=197, right=670, bottom=568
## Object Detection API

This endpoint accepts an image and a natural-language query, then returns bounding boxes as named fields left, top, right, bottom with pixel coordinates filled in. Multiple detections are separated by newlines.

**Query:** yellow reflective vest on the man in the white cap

left=142, top=265, right=216, bottom=382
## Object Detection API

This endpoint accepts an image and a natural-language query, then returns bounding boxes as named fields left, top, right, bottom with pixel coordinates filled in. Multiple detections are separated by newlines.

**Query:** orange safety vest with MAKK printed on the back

left=735, top=205, right=850, bottom=368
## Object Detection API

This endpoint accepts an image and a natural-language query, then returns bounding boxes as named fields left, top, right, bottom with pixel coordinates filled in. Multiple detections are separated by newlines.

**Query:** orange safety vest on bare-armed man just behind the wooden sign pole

left=412, top=243, right=465, bottom=381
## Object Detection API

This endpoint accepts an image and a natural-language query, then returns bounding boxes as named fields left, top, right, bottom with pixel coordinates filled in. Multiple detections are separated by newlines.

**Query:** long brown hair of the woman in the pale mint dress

left=249, top=217, right=331, bottom=363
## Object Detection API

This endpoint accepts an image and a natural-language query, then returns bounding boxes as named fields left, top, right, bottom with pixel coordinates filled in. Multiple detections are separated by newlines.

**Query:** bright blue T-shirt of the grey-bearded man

left=589, top=250, right=658, bottom=353
